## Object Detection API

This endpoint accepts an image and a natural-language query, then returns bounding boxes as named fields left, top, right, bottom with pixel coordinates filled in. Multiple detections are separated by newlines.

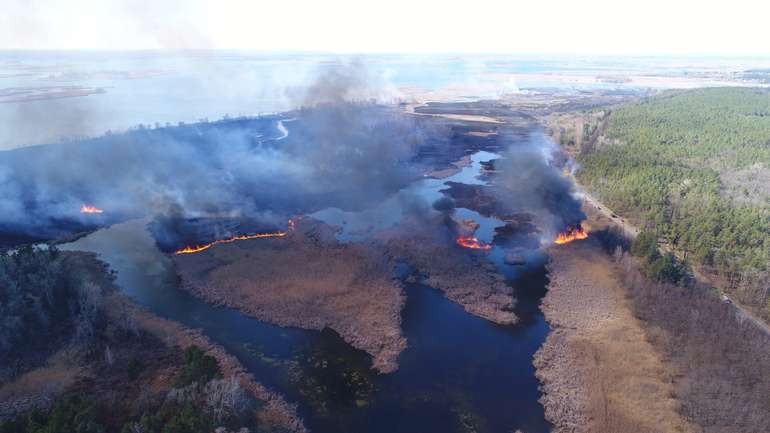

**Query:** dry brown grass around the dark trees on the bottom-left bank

left=0, top=252, right=307, bottom=433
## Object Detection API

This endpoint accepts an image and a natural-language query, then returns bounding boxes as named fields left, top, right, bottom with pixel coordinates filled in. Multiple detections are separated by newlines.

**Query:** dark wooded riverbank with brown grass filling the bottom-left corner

left=0, top=246, right=260, bottom=433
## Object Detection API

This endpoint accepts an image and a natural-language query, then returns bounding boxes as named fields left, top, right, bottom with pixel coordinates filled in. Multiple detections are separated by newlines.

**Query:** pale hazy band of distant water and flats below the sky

left=0, top=49, right=770, bottom=149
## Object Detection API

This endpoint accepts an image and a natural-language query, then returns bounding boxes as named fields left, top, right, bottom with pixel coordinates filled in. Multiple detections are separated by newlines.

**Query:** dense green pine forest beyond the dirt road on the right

left=577, top=89, right=770, bottom=317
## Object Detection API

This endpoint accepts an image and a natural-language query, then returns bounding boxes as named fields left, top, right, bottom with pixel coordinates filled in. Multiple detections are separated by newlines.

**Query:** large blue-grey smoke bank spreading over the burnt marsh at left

left=0, top=63, right=432, bottom=241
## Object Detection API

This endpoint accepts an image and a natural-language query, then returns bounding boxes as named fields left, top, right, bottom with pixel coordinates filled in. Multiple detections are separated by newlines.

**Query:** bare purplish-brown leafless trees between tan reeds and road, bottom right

left=615, top=246, right=770, bottom=433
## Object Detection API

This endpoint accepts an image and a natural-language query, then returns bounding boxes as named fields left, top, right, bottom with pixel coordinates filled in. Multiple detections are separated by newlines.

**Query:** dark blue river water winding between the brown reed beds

left=62, top=149, right=550, bottom=433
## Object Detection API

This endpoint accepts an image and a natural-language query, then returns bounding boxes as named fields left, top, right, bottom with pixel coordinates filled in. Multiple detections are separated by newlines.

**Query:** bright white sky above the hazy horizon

left=0, top=0, right=770, bottom=56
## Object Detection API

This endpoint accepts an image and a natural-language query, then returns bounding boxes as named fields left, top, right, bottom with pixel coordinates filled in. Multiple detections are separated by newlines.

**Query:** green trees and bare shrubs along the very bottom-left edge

left=0, top=346, right=256, bottom=433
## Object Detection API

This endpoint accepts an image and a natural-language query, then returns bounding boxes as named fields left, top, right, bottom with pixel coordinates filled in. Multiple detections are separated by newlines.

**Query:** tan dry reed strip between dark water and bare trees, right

left=535, top=240, right=692, bottom=433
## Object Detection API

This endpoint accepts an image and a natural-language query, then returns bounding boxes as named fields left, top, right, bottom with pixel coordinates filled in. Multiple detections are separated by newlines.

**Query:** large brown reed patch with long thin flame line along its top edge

left=175, top=220, right=406, bottom=372
